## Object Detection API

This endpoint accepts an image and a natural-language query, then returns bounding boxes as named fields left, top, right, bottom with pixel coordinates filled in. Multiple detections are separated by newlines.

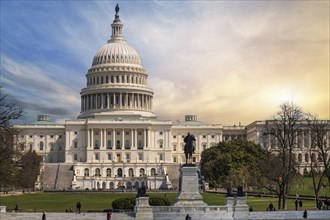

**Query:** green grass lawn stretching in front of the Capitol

left=0, top=192, right=315, bottom=212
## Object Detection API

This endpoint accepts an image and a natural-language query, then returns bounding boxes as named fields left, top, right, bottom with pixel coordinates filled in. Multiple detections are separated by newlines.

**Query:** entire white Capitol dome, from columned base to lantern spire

left=78, top=6, right=156, bottom=118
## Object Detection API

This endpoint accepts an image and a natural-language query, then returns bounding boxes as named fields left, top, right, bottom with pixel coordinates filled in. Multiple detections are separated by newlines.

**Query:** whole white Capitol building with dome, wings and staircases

left=15, top=6, right=329, bottom=190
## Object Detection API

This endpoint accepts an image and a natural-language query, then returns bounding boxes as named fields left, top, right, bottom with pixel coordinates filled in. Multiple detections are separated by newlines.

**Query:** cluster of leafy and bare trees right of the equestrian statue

left=201, top=103, right=330, bottom=209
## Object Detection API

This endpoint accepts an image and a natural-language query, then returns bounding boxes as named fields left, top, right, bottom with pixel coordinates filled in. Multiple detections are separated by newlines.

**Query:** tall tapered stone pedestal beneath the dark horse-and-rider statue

left=174, top=165, right=207, bottom=206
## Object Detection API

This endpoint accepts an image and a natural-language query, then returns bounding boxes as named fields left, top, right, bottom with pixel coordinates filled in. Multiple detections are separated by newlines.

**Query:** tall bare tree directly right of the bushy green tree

left=264, top=103, right=306, bottom=209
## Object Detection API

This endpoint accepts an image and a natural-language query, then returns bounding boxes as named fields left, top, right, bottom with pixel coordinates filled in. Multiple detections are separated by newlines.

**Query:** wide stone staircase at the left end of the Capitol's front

left=42, top=163, right=73, bottom=190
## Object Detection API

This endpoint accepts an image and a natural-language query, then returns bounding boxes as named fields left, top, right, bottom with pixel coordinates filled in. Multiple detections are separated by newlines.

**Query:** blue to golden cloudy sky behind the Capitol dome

left=0, top=0, right=330, bottom=125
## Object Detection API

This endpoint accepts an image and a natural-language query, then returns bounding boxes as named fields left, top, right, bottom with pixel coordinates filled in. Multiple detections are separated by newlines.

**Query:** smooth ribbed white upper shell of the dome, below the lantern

left=92, top=40, right=142, bottom=67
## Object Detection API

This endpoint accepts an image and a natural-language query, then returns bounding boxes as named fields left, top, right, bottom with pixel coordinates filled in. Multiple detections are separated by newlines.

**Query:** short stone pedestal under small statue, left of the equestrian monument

left=134, top=197, right=153, bottom=220
